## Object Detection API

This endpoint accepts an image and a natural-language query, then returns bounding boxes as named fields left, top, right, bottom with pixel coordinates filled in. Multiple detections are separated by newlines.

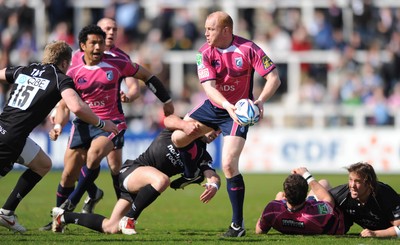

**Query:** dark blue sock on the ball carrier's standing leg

left=226, top=174, right=245, bottom=226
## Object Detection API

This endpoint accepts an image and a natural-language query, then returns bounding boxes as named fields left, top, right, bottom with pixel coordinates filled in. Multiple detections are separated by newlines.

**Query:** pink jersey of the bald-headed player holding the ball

left=196, top=35, right=275, bottom=108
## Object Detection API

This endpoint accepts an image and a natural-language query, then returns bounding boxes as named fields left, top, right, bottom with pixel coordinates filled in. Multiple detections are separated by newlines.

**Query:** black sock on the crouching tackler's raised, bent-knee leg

left=128, top=184, right=160, bottom=220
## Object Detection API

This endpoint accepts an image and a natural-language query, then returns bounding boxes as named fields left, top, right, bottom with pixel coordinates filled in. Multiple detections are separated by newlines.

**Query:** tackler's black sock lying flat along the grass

left=64, top=212, right=106, bottom=232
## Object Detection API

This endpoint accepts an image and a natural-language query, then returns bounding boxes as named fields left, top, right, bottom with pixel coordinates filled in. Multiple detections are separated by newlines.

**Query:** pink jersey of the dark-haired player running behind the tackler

left=67, top=52, right=139, bottom=120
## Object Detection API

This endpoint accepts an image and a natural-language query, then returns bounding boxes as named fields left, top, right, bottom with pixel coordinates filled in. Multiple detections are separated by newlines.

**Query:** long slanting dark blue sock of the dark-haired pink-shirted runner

left=68, top=165, right=100, bottom=205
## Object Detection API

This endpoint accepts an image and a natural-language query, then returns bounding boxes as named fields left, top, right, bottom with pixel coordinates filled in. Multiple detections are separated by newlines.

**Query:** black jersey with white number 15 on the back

left=0, top=63, right=75, bottom=154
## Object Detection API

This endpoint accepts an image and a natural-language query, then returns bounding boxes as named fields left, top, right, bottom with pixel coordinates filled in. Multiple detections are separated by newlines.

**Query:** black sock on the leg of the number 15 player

left=3, top=168, right=42, bottom=211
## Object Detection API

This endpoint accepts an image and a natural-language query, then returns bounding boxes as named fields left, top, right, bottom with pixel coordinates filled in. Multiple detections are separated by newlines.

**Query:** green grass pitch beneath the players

left=0, top=171, right=400, bottom=245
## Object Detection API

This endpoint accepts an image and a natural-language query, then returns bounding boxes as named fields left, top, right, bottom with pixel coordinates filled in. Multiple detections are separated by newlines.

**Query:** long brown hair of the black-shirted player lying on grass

left=346, top=162, right=378, bottom=194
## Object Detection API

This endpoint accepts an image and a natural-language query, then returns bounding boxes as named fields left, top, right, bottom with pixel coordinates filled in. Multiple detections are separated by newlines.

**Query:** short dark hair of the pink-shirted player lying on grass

left=283, top=174, right=308, bottom=205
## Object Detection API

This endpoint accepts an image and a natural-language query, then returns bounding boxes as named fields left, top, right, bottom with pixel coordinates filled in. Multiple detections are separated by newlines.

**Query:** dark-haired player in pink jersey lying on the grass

left=256, top=167, right=344, bottom=235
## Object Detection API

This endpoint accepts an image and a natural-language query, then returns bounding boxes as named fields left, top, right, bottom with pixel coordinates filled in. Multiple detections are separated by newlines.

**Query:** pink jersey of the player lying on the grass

left=260, top=200, right=344, bottom=235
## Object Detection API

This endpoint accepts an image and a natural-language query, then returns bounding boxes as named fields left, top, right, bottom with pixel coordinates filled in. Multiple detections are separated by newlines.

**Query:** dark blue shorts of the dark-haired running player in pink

left=69, top=118, right=126, bottom=149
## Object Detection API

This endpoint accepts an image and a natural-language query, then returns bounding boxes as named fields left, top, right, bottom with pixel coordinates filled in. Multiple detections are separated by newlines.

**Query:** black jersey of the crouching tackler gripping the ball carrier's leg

left=122, top=129, right=214, bottom=177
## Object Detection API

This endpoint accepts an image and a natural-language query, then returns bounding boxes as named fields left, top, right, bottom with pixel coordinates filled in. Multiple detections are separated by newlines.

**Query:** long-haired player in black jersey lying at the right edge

left=329, top=162, right=400, bottom=237
